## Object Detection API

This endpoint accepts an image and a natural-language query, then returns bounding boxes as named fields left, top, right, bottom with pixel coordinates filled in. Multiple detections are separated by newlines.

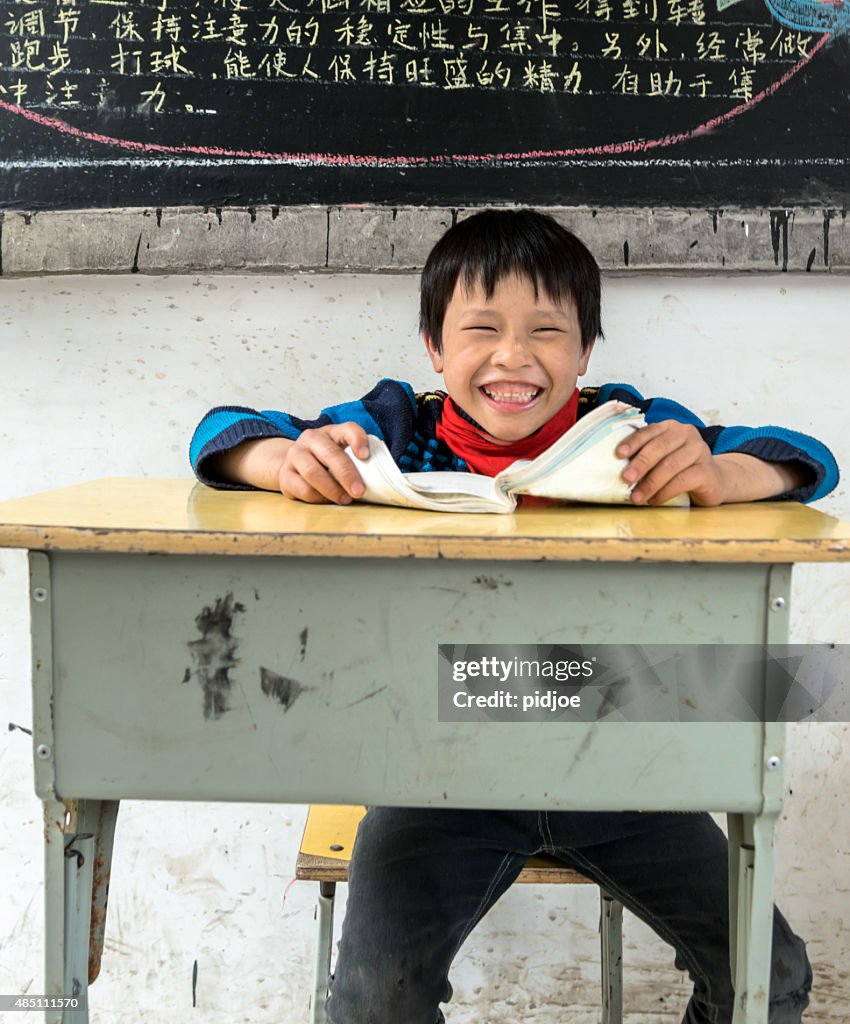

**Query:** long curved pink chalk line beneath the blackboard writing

left=0, top=33, right=831, bottom=167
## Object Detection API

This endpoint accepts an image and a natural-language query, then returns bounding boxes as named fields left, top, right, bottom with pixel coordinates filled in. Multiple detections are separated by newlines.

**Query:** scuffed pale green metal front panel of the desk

left=33, top=552, right=787, bottom=811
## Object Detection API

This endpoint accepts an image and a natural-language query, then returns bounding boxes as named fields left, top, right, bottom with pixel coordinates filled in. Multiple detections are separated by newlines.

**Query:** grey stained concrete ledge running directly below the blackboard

left=0, top=206, right=850, bottom=276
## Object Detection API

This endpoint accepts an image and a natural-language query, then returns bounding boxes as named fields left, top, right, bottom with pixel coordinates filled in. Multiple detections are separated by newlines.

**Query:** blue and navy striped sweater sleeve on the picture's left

left=189, top=379, right=416, bottom=490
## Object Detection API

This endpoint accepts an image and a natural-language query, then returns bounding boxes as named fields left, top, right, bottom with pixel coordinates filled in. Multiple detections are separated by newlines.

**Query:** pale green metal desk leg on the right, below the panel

left=727, top=813, right=778, bottom=1024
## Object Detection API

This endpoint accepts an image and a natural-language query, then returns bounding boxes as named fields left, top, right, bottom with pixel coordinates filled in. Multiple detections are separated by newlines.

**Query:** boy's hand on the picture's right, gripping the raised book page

left=617, top=420, right=725, bottom=505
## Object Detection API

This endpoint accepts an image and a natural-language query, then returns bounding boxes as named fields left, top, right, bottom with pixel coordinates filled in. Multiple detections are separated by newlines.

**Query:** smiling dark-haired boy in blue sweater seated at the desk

left=192, top=211, right=838, bottom=1024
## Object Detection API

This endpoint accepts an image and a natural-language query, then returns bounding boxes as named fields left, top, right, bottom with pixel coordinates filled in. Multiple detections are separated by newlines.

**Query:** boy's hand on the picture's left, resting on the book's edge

left=279, top=423, right=369, bottom=505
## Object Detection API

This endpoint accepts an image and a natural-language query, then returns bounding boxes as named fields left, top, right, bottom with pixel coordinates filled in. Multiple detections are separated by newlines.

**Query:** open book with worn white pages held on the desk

left=345, top=401, right=689, bottom=512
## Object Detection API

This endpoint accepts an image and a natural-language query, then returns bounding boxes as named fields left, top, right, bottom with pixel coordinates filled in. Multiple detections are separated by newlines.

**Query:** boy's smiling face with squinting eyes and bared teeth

left=425, top=274, right=593, bottom=443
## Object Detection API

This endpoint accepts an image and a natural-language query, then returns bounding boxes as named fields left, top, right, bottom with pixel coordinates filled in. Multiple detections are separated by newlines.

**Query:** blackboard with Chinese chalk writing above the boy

left=0, top=0, right=850, bottom=210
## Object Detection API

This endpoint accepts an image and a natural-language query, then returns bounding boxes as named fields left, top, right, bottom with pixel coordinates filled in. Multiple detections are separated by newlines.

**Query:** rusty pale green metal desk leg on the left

left=44, top=801, right=119, bottom=1024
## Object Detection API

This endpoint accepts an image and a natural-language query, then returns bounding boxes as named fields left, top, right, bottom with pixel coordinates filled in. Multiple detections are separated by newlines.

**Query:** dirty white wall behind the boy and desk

left=0, top=274, right=850, bottom=1024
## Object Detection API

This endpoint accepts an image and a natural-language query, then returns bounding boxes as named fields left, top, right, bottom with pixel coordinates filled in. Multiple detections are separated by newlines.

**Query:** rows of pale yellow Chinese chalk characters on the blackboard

left=0, top=0, right=819, bottom=118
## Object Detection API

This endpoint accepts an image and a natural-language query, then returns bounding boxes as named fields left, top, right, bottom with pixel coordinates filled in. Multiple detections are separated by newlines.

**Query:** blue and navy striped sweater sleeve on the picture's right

left=596, top=384, right=839, bottom=502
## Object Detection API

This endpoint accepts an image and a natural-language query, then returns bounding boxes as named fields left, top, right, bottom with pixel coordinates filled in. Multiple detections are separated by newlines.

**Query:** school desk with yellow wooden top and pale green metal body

left=0, top=478, right=850, bottom=1024
